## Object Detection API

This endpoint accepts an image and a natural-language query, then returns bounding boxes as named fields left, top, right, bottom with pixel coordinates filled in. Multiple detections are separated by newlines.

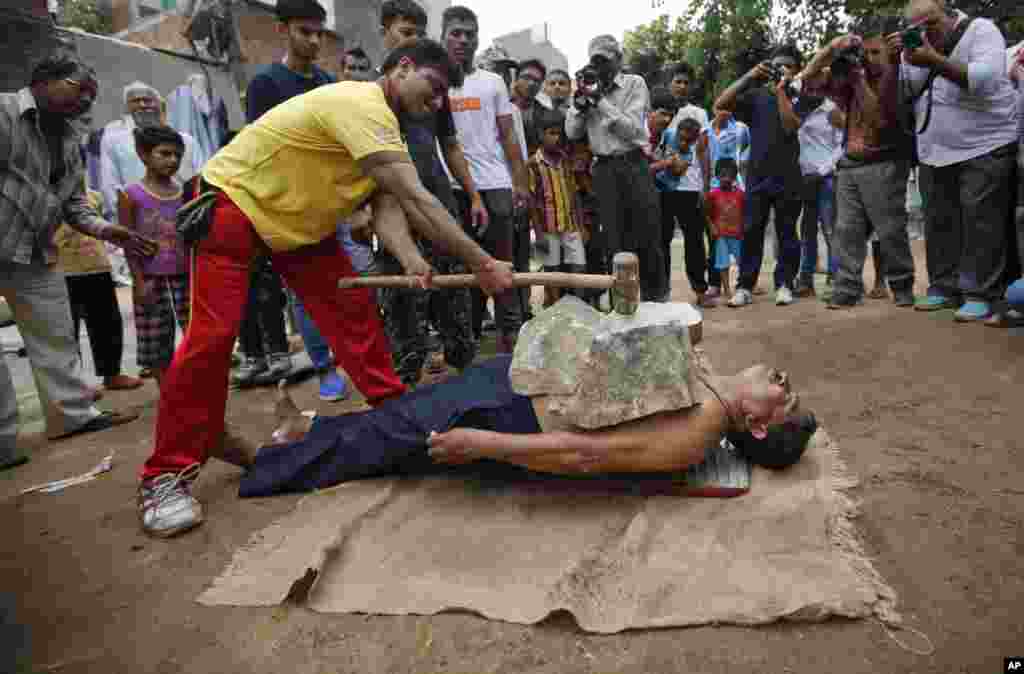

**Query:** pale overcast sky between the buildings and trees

left=471, top=0, right=675, bottom=73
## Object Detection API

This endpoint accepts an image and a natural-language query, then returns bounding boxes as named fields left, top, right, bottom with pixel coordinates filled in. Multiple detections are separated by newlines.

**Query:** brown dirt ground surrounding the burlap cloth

left=0, top=242, right=1024, bottom=674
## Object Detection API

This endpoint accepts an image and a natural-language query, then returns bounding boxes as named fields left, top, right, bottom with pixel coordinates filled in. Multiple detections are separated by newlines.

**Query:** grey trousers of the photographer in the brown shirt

left=833, top=160, right=913, bottom=300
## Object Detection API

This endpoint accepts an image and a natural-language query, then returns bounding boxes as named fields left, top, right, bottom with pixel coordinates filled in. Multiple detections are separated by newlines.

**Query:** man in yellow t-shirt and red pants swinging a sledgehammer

left=138, top=40, right=512, bottom=537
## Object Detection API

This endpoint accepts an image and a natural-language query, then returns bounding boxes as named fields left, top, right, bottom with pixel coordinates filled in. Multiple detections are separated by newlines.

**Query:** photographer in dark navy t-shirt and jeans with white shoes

left=715, top=45, right=806, bottom=307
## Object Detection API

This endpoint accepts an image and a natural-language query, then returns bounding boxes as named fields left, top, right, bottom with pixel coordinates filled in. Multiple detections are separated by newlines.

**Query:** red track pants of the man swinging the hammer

left=142, top=195, right=406, bottom=479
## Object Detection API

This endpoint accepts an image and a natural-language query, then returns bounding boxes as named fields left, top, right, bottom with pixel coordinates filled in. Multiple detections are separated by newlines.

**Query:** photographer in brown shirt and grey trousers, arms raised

left=801, top=17, right=913, bottom=309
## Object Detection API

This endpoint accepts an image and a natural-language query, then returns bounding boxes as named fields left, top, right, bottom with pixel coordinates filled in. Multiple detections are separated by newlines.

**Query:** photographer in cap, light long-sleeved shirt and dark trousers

left=565, top=35, right=670, bottom=301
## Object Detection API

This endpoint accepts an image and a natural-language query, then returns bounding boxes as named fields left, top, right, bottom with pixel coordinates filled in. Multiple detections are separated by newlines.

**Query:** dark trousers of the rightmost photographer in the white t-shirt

left=918, top=143, right=1017, bottom=302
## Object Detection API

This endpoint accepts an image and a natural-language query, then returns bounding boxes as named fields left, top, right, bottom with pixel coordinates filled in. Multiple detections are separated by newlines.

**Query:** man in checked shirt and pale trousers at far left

left=0, top=54, right=157, bottom=467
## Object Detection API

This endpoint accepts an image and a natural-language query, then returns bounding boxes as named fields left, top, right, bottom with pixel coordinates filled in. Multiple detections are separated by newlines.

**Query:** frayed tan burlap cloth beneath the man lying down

left=199, top=429, right=899, bottom=633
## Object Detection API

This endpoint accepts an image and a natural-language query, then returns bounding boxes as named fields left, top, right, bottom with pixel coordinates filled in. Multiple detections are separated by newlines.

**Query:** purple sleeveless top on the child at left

left=125, top=182, right=188, bottom=277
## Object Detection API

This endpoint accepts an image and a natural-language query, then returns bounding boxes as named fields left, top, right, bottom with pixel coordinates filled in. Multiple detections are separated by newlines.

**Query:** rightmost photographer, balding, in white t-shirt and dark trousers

left=889, top=0, right=1017, bottom=322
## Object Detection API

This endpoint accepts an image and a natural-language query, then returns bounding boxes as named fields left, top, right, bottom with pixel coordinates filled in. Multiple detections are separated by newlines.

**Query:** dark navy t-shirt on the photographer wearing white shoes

left=735, top=86, right=806, bottom=193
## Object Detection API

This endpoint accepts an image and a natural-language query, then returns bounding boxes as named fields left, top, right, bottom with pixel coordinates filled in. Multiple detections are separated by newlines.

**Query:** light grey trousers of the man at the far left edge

left=0, top=262, right=99, bottom=459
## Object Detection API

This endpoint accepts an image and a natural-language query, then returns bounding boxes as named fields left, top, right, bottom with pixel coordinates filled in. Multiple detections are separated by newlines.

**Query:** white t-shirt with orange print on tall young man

left=449, top=69, right=516, bottom=189
